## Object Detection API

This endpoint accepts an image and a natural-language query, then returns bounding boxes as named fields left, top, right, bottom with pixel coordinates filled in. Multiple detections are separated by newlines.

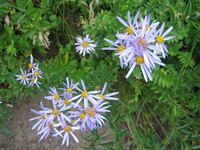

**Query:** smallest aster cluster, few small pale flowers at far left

left=15, top=55, right=42, bottom=88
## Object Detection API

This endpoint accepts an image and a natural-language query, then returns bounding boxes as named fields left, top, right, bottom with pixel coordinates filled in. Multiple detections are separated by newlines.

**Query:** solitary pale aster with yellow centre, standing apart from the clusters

left=75, top=34, right=97, bottom=56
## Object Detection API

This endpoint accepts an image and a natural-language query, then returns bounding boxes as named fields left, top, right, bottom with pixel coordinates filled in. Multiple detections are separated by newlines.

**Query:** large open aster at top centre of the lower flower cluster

left=71, top=80, right=99, bottom=108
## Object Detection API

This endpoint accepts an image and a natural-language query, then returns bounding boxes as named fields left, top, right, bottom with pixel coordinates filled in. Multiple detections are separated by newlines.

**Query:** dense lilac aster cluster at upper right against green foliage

left=102, top=11, right=175, bottom=82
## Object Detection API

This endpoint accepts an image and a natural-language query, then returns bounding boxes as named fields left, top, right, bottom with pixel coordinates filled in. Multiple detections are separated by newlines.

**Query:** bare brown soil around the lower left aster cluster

left=0, top=96, right=111, bottom=150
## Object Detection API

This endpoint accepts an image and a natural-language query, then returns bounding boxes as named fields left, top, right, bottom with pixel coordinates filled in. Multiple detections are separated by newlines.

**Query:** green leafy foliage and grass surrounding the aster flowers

left=0, top=0, right=200, bottom=150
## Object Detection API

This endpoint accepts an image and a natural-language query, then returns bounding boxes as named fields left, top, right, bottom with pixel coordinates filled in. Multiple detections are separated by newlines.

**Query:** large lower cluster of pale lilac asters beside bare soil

left=30, top=77, right=118, bottom=146
